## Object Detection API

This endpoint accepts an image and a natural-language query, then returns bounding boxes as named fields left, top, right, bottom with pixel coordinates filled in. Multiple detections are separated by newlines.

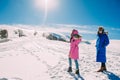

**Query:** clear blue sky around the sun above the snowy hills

left=0, top=0, right=120, bottom=27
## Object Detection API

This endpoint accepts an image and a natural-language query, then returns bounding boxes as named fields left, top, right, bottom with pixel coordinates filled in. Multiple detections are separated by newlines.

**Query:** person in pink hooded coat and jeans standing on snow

left=68, top=29, right=81, bottom=74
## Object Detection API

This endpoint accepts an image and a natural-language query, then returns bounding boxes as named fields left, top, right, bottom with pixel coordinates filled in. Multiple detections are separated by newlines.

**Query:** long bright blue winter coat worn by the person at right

left=96, top=33, right=109, bottom=63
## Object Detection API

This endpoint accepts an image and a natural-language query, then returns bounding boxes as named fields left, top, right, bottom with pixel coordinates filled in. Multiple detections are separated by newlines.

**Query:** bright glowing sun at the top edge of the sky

left=34, top=0, right=58, bottom=11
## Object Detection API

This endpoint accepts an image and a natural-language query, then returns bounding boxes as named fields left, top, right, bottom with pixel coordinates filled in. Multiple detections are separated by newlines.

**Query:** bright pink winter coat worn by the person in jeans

left=69, top=38, right=81, bottom=60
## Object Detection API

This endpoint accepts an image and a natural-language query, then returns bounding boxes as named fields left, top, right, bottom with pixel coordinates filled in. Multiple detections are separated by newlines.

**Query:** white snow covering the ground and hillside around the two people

left=0, top=25, right=120, bottom=80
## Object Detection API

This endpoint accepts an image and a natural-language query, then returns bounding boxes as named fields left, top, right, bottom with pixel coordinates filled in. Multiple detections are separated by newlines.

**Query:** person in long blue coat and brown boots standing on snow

left=96, top=27, right=109, bottom=72
